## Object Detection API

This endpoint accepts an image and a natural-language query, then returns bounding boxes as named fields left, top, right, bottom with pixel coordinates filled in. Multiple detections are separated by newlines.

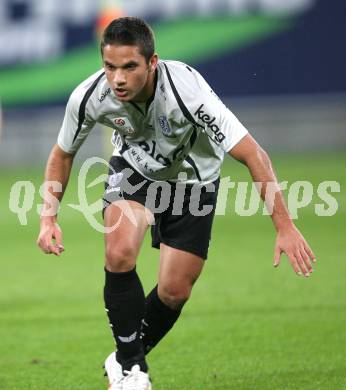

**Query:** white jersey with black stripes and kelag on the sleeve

left=58, top=60, right=247, bottom=183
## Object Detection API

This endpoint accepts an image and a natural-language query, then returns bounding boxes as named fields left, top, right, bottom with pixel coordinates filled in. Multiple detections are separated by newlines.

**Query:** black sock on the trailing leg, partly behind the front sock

left=142, top=285, right=181, bottom=354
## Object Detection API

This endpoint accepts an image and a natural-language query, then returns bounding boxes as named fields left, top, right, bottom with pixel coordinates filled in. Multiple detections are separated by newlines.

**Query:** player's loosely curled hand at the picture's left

left=37, top=220, right=65, bottom=256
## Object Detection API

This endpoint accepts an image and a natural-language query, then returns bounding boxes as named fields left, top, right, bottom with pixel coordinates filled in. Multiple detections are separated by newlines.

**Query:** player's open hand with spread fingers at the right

left=274, top=225, right=316, bottom=277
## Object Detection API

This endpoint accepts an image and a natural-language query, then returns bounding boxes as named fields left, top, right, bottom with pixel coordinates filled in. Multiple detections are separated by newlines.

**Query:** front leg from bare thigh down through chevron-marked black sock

left=104, top=200, right=148, bottom=372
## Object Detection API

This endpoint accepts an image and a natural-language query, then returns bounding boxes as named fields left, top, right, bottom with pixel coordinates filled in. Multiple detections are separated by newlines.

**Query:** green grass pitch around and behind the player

left=0, top=154, right=346, bottom=390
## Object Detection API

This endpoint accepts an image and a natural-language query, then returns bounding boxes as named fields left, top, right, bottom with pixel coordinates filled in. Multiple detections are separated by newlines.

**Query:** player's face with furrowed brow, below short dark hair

left=103, top=45, right=158, bottom=102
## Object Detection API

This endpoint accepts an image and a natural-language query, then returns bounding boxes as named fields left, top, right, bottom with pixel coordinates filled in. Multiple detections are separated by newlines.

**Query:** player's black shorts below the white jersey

left=103, top=156, right=219, bottom=259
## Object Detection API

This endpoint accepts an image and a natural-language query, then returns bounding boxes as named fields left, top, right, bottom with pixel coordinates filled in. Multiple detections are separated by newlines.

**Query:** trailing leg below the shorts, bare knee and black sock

left=142, top=243, right=204, bottom=353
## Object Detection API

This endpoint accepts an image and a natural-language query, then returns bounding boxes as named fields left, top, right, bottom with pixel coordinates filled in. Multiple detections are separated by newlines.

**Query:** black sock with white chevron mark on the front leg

left=104, top=269, right=148, bottom=372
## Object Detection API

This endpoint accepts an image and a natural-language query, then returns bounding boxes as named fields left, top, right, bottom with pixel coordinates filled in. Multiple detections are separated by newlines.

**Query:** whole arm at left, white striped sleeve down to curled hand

left=37, top=71, right=102, bottom=256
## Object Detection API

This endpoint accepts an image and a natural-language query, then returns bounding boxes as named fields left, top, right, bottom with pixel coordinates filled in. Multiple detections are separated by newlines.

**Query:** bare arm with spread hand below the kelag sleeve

left=228, top=134, right=316, bottom=276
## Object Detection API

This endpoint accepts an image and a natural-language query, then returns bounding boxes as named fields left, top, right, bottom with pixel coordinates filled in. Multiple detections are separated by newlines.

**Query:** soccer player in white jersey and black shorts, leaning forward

left=38, top=17, right=315, bottom=390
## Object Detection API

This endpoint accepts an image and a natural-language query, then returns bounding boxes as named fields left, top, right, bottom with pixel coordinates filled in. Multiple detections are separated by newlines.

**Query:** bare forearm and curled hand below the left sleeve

left=37, top=145, right=74, bottom=256
